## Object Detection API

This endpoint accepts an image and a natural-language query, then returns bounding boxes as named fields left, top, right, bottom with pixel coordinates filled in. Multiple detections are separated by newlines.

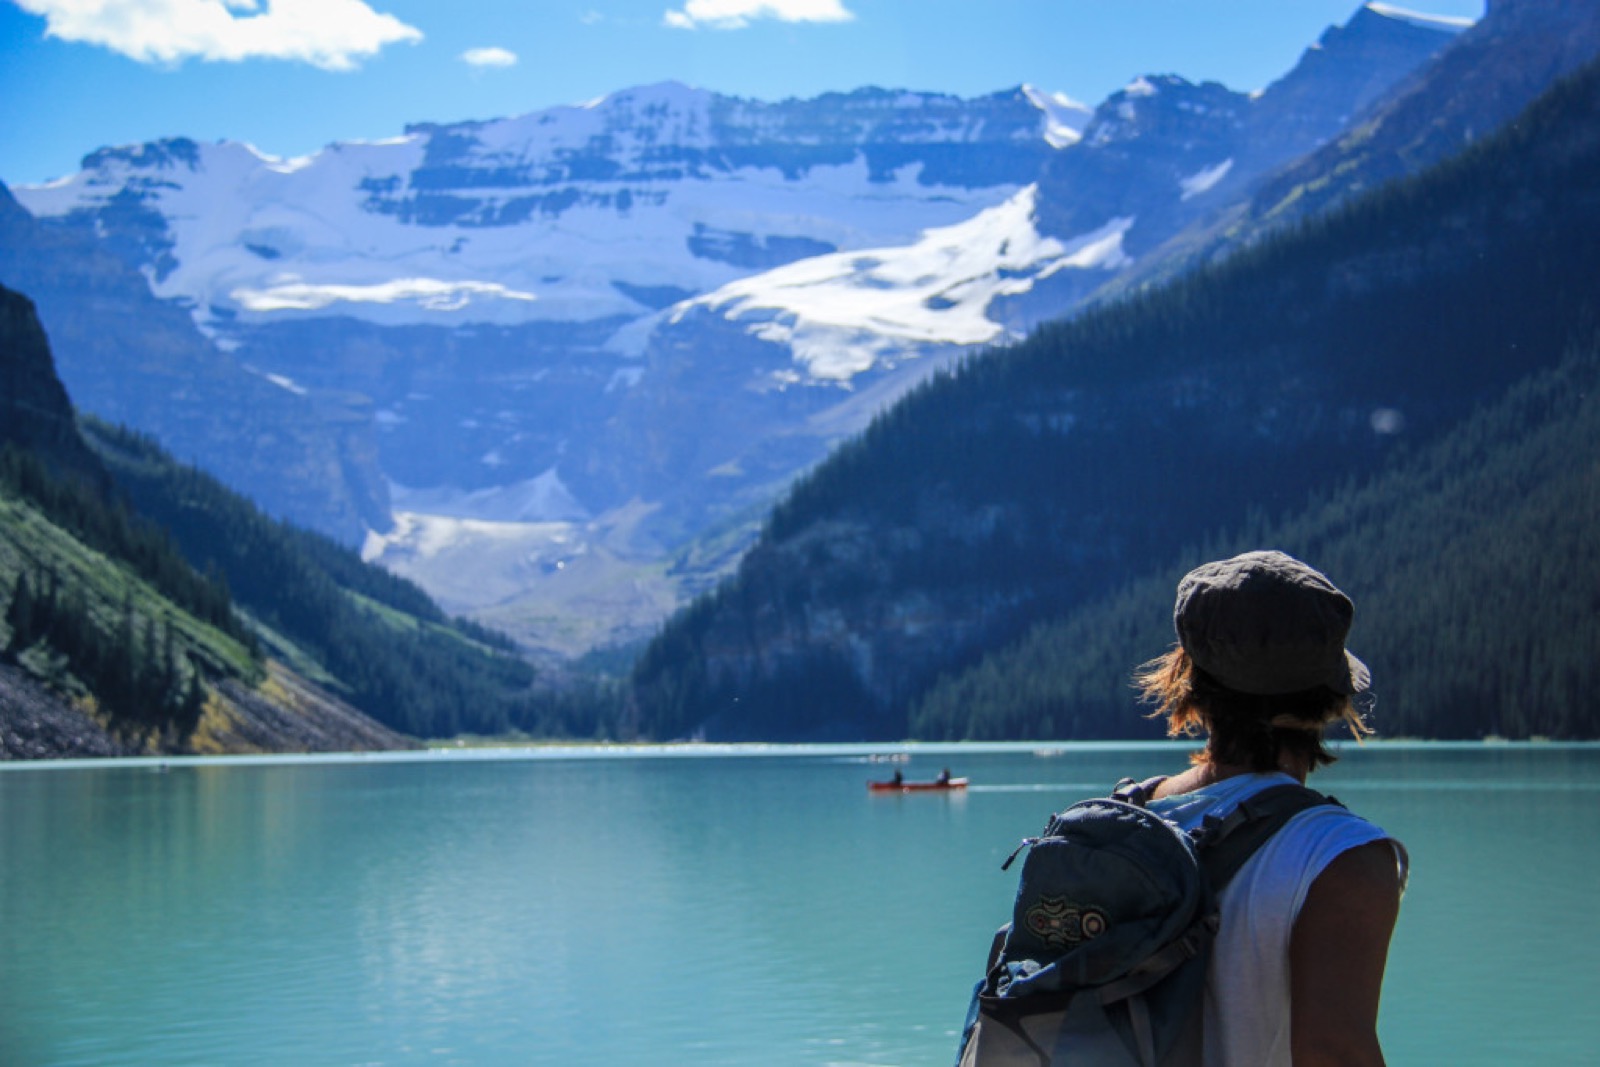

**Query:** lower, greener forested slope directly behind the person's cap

left=909, top=336, right=1600, bottom=741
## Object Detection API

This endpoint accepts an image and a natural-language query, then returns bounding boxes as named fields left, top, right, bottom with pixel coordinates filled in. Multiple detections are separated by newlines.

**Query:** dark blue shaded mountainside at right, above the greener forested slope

left=635, top=58, right=1600, bottom=737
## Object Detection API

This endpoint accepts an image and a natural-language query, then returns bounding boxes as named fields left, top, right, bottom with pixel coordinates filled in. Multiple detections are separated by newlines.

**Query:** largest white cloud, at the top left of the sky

left=16, top=0, right=422, bottom=70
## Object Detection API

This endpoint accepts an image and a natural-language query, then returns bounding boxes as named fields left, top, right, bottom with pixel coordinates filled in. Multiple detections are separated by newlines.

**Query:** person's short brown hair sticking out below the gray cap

left=1133, top=646, right=1373, bottom=771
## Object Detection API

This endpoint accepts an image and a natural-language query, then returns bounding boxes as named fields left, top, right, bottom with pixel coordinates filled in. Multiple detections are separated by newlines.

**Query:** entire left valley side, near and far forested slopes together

left=0, top=279, right=600, bottom=755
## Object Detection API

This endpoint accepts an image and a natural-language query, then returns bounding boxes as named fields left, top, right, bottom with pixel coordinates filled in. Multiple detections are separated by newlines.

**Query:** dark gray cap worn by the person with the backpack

left=1173, top=552, right=1371, bottom=696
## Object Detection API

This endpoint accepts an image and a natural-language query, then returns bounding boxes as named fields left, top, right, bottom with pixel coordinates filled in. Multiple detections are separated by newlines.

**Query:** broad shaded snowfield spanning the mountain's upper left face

left=18, top=134, right=1016, bottom=334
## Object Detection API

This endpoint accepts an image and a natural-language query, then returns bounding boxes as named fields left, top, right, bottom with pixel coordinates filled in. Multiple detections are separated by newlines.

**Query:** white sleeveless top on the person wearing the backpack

left=1150, top=773, right=1405, bottom=1067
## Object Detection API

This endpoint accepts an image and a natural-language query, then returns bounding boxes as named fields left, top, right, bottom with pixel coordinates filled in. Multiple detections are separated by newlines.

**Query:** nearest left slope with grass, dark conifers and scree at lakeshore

left=0, top=288, right=414, bottom=758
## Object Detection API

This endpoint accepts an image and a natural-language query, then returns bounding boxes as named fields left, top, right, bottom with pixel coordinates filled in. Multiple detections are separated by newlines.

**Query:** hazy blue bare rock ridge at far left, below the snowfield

left=0, top=186, right=389, bottom=539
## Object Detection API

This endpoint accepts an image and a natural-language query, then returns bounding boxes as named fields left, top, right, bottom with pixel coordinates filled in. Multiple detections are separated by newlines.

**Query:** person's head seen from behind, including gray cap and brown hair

left=1136, top=552, right=1371, bottom=771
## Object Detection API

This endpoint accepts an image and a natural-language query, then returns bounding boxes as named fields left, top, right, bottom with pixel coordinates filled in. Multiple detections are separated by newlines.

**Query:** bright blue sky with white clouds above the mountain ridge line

left=0, top=0, right=1483, bottom=184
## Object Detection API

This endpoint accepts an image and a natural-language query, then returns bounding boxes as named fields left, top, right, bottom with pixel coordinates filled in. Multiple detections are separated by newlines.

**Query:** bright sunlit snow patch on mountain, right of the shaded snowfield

left=672, top=186, right=1133, bottom=382
